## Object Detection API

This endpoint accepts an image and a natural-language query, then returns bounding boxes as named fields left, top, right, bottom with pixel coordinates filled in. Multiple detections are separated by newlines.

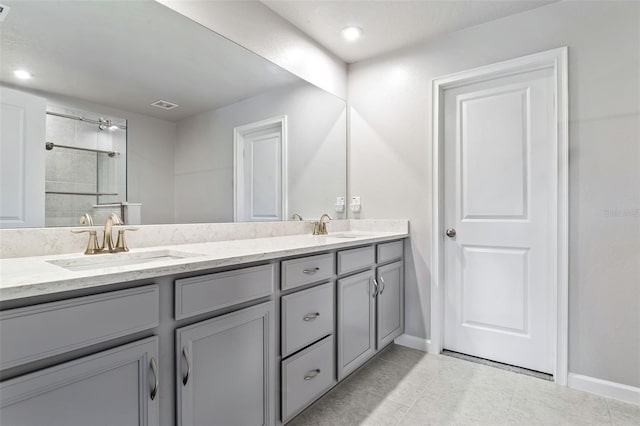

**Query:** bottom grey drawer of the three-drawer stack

left=282, top=336, right=335, bottom=422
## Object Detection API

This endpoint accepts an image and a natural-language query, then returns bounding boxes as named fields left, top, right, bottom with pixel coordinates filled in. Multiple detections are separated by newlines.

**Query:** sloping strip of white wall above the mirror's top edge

left=157, top=0, right=347, bottom=99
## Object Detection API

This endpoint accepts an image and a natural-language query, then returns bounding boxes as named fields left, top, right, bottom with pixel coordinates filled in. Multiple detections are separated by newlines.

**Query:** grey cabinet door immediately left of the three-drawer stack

left=176, top=302, right=275, bottom=426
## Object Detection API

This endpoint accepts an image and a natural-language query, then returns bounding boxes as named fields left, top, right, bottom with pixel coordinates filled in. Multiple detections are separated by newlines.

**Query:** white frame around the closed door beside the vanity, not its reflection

left=428, top=46, right=569, bottom=386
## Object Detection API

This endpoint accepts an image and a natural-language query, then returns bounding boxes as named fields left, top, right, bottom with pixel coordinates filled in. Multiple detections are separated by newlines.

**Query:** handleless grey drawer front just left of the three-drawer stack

left=175, top=265, right=275, bottom=320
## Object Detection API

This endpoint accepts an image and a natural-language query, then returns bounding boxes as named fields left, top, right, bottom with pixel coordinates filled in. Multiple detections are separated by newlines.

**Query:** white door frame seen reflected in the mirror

left=233, top=115, right=288, bottom=222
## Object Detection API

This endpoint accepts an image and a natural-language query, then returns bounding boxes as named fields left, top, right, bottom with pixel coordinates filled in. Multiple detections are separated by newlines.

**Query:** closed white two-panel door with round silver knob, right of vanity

left=443, top=68, right=558, bottom=373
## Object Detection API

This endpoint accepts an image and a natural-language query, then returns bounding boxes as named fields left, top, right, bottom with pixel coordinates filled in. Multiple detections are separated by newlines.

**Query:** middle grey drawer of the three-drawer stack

left=281, top=283, right=334, bottom=357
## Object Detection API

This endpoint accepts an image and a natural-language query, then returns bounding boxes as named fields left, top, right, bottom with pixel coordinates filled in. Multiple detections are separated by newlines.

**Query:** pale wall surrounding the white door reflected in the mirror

left=175, top=82, right=346, bottom=223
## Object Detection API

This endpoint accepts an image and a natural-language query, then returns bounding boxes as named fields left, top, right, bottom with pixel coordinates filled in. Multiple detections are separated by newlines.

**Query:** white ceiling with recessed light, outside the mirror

left=261, top=0, right=557, bottom=63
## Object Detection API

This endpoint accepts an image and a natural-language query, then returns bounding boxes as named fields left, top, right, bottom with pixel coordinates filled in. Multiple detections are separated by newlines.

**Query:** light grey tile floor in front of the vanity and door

left=287, top=344, right=640, bottom=426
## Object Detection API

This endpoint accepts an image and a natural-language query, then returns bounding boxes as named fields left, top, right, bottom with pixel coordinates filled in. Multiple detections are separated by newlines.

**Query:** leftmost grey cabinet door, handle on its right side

left=0, top=337, right=159, bottom=426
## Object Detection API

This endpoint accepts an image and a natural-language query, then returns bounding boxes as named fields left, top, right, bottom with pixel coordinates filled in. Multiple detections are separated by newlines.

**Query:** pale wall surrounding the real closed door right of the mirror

left=349, top=2, right=640, bottom=386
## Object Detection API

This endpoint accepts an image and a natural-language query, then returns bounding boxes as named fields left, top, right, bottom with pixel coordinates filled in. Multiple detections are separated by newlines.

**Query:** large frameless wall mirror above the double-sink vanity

left=0, top=0, right=346, bottom=228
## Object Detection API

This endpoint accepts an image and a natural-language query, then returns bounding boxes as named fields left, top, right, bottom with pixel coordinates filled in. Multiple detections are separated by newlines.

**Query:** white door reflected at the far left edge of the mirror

left=0, top=87, right=46, bottom=228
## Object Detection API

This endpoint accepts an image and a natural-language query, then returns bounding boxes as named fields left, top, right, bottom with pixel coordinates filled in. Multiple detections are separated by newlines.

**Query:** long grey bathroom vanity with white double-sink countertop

left=0, top=232, right=407, bottom=426
